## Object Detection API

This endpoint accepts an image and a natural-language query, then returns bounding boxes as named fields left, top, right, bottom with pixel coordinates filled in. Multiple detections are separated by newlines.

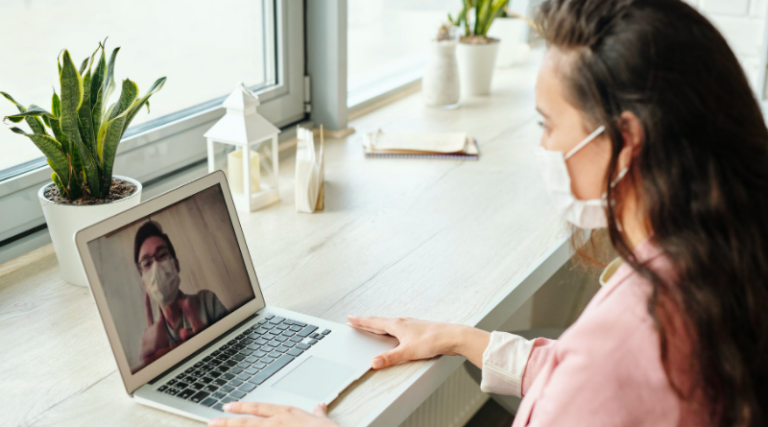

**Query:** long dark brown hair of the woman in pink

left=537, top=0, right=768, bottom=427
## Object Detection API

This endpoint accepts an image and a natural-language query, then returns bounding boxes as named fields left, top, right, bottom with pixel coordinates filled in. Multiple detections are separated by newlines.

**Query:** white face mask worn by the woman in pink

left=536, top=126, right=628, bottom=229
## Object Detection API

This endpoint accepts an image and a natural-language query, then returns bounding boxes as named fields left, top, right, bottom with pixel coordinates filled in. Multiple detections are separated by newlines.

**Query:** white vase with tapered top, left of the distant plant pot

left=421, top=40, right=461, bottom=109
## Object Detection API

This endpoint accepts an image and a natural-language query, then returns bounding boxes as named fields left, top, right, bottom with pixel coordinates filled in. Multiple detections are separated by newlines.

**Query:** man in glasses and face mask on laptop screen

left=133, top=221, right=228, bottom=365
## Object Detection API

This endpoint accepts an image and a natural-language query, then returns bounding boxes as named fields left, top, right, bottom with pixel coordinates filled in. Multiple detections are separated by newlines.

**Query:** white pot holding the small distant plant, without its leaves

left=456, top=41, right=499, bottom=96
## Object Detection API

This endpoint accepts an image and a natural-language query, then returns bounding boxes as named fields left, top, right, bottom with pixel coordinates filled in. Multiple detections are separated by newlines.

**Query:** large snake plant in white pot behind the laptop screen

left=0, top=43, right=165, bottom=286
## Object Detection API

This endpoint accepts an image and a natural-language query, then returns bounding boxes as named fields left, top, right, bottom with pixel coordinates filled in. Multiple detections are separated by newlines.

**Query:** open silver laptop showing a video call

left=75, top=171, right=397, bottom=421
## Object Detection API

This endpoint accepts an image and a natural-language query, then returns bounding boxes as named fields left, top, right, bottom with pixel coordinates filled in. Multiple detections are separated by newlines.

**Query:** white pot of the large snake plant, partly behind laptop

left=37, top=176, right=141, bottom=286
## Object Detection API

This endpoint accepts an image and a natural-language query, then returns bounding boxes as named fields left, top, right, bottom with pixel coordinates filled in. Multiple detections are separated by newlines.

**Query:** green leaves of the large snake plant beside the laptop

left=0, top=43, right=166, bottom=200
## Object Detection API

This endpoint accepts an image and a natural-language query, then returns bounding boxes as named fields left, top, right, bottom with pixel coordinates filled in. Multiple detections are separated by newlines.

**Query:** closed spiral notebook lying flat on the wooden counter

left=363, top=131, right=480, bottom=160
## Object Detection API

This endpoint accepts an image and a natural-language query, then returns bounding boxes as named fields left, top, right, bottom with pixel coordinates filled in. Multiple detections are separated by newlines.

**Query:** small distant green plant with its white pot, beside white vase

left=448, top=0, right=509, bottom=96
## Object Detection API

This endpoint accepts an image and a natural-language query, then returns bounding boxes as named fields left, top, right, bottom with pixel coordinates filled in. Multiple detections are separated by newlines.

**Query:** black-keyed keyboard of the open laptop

left=157, top=315, right=331, bottom=411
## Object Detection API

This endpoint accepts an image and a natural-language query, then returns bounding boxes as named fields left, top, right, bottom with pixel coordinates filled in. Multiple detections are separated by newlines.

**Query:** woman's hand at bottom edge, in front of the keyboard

left=208, top=402, right=338, bottom=427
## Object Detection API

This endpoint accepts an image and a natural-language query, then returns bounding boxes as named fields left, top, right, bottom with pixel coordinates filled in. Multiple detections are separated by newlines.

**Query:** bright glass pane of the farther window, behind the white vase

left=347, top=0, right=450, bottom=100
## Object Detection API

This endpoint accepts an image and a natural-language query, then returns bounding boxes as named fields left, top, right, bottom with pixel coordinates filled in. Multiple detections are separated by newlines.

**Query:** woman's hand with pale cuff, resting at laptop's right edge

left=349, top=316, right=490, bottom=369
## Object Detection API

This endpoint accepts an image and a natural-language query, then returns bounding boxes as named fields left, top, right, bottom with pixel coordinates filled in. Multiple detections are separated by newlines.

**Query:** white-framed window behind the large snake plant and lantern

left=0, top=0, right=306, bottom=246
